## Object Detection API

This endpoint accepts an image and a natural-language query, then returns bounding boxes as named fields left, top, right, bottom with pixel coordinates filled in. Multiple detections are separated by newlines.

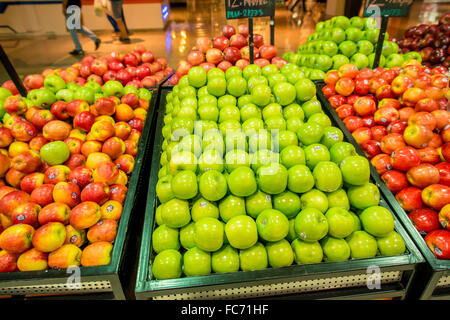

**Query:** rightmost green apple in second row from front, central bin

left=359, top=206, right=395, bottom=237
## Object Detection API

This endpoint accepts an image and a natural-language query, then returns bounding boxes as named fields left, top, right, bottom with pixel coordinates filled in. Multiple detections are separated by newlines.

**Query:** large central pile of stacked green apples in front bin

left=151, top=64, right=405, bottom=280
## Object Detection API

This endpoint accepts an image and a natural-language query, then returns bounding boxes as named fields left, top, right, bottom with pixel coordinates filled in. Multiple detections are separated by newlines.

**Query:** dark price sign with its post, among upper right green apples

left=363, top=0, right=413, bottom=69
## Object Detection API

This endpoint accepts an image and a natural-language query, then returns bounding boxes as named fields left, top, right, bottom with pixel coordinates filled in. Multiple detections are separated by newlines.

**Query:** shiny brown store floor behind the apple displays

left=0, top=0, right=450, bottom=82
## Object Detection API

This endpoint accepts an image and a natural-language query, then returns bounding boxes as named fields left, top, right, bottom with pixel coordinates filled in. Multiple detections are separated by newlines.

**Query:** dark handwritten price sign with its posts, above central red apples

left=225, top=0, right=275, bottom=63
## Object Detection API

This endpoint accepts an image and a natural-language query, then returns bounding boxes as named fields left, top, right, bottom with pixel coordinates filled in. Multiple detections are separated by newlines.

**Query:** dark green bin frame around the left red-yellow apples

left=0, top=89, right=158, bottom=299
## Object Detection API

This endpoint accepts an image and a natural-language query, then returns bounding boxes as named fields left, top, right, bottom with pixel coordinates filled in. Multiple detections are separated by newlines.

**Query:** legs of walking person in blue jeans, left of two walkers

left=62, top=0, right=101, bottom=56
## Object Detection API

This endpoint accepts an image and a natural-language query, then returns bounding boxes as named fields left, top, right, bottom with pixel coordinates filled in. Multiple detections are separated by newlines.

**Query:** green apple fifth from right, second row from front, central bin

left=225, top=215, right=258, bottom=249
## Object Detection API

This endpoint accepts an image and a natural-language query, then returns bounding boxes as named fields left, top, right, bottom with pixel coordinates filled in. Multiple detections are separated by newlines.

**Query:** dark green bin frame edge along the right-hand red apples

left=316, top=81, right=450, bottom=299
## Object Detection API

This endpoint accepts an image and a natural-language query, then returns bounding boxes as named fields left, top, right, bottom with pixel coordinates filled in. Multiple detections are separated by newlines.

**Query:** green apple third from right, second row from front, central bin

left=294, top=207, right=328, bottom=242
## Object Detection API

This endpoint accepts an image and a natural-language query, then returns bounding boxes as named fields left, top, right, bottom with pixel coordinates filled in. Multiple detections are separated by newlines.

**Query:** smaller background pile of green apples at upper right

left=283, top=16, right=421, bottom=80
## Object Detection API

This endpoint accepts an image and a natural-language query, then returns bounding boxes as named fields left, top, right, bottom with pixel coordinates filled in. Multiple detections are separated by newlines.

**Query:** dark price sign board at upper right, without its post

left=363, top=0, right=413, bottom=17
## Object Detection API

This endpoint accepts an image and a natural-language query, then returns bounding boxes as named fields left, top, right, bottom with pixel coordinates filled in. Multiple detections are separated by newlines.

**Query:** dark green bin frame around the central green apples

left=136, top=87, right=424, bottom=299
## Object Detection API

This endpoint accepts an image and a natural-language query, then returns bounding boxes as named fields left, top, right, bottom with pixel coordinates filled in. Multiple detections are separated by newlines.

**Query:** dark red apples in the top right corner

left=393, top=12, right=450, bottom=68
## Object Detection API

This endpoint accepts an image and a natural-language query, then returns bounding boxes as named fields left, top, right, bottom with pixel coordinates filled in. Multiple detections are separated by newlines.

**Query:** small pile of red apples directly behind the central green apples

left=169, top=24, right=287, bottom=85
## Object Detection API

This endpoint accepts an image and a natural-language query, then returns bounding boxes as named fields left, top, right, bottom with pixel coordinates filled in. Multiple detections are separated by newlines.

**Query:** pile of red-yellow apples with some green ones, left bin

left=0, top=49, right=152, bottom=272
